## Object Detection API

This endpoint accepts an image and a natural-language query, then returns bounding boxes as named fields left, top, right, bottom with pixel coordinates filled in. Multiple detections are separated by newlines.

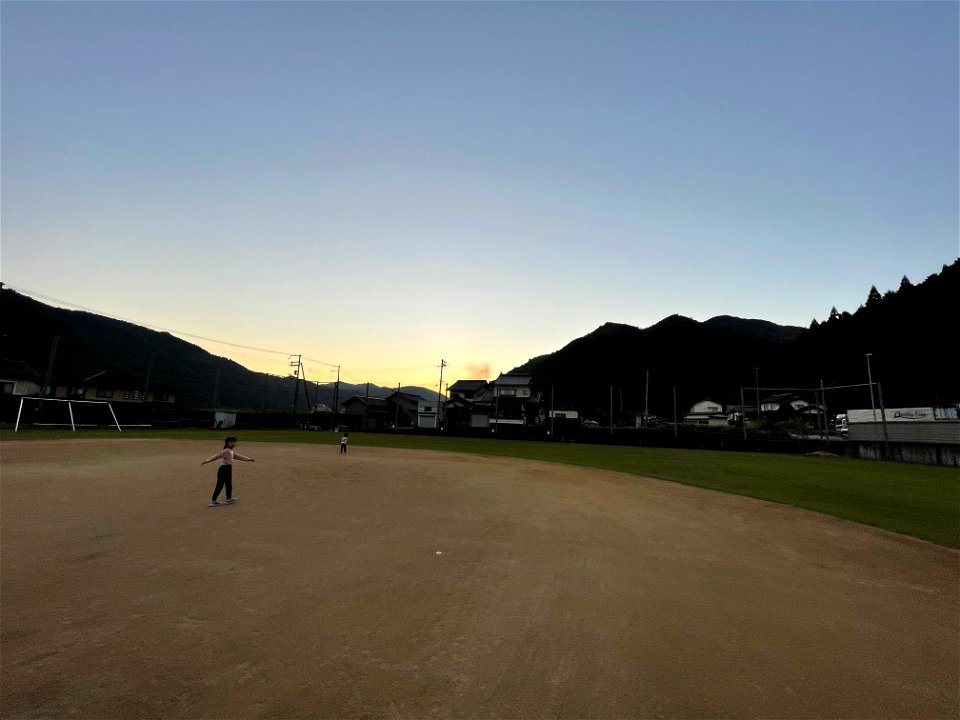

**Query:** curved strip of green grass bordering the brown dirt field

left=0, top=428, right=960, bottom=548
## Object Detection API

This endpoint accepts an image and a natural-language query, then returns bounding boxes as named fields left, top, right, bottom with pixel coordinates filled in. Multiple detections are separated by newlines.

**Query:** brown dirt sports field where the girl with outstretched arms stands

left=0, top=440, right=960, bottom=719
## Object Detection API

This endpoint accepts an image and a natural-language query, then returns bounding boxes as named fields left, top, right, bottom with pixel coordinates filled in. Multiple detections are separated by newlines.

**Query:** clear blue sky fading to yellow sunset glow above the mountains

left=0, top=1, right=960, bottom=394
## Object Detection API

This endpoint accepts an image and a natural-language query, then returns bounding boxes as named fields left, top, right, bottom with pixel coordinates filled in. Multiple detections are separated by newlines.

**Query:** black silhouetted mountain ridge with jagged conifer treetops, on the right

left=515, top=261, right=960, bottom=419
